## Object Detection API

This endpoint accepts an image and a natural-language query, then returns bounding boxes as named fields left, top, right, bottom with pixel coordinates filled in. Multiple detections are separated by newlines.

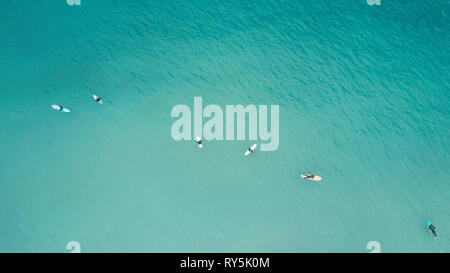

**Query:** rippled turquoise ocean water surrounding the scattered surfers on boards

left=0, top=0, right=450, bottom=252
